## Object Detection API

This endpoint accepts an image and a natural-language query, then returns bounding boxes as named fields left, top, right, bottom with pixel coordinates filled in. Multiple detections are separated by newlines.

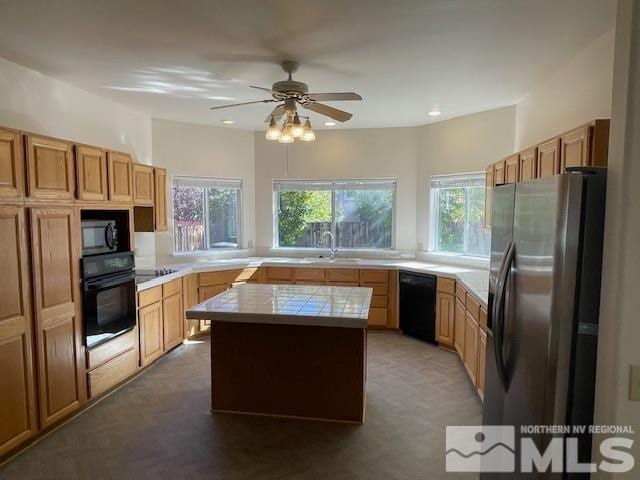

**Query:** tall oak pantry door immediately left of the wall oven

left=31, top=208, right=86, bottom=428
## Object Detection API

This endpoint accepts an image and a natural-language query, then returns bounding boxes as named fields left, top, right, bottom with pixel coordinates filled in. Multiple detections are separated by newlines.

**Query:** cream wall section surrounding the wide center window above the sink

left=255, top=128, right=418, bottom=253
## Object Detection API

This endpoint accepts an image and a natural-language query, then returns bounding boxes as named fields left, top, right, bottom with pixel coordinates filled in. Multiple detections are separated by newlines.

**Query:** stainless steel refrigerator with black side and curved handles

left=481, top=168, right=606, bottom=480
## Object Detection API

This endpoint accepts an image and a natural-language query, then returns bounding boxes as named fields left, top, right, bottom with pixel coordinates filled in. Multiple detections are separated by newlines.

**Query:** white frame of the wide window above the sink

left=271, top=178, right=398, bottom=252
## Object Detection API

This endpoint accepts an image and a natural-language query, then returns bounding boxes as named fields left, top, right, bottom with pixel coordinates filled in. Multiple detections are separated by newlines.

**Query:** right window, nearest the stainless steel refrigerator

left=431, top=173, right=491, bottom=257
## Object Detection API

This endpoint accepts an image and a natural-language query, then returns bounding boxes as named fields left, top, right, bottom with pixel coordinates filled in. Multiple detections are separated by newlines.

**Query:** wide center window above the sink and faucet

left=273, top=180, right=396, bottom=249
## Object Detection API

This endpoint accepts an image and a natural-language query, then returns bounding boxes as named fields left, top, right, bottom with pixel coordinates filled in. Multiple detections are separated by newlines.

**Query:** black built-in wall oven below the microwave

left=82, top=252, right=136, bottom=348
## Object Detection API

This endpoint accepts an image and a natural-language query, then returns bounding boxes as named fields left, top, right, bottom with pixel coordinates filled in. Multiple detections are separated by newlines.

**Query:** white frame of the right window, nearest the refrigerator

left=428, top=172, right=491, bottom=260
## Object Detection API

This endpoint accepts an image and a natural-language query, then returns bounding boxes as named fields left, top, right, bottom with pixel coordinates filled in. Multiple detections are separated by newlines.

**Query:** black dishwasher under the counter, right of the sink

left=399, top=271, right=436, bottom=343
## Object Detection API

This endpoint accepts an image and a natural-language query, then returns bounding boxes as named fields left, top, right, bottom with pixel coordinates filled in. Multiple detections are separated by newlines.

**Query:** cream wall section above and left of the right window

left=416, top=106, right=515, bottom=251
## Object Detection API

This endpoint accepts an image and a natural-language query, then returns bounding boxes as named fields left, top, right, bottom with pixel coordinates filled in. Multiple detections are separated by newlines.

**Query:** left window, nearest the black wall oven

left=173, top=177, right=242, bottom=253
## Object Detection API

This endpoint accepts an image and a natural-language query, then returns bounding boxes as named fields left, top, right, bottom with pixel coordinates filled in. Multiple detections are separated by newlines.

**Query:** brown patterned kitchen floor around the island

left=0, top=333, right=481, bottom=480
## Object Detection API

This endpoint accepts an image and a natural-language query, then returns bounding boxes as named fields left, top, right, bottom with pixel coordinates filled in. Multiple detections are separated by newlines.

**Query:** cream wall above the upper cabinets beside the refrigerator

left=515, top=29, right=614, bottom=150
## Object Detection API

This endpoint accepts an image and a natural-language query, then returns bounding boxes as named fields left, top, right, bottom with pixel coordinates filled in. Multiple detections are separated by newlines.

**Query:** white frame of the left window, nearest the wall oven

left=171, top=175, right=244, bottom=256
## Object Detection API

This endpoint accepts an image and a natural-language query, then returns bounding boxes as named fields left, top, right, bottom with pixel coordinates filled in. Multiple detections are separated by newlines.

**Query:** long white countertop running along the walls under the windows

left=137, top=257, right=489, bottom=308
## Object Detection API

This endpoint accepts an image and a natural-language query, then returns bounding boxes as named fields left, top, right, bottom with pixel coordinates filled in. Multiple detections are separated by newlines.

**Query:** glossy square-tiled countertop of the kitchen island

left=187, top=283, right=373, bottom=328
